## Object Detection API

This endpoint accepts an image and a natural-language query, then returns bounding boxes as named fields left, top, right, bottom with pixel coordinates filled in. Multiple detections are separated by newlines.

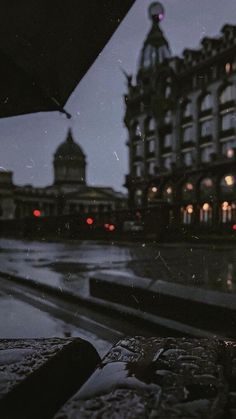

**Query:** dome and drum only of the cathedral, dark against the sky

left=53, top=129, right=86, bottom=187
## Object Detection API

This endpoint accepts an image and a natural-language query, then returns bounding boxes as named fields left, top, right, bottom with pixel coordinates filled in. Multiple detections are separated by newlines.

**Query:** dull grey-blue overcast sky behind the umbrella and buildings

left=0, top=0, right=236, bottom=190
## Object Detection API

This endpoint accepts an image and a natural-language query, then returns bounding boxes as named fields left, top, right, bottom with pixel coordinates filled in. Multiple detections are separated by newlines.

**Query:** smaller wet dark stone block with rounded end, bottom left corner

left=0, top=338, right=100, bottom=419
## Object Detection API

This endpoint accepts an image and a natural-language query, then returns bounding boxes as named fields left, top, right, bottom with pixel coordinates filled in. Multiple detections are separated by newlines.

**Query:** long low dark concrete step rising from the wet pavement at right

left=90, top=271, right=236, bottom=339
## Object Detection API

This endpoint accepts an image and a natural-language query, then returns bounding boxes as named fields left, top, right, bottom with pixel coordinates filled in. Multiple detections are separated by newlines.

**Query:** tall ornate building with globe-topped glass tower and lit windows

left=125, top=3, right=236, bottom=230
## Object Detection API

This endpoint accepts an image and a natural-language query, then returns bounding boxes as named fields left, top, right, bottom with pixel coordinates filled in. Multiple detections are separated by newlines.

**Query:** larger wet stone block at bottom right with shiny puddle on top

left=55, top=337, right=236, bottom=419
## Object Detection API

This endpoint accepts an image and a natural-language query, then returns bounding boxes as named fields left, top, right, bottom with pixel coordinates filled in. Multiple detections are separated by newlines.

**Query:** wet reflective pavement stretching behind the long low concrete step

left=0, top=239, right=236, bottom=295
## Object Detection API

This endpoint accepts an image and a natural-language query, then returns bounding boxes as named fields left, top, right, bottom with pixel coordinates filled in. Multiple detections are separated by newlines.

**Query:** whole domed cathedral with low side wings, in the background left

left=0, top=131, right=126, bottom=219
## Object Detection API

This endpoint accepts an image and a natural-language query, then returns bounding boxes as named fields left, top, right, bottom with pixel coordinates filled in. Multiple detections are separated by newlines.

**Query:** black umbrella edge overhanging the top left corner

left=0, top=0, right=134, bottom=117
